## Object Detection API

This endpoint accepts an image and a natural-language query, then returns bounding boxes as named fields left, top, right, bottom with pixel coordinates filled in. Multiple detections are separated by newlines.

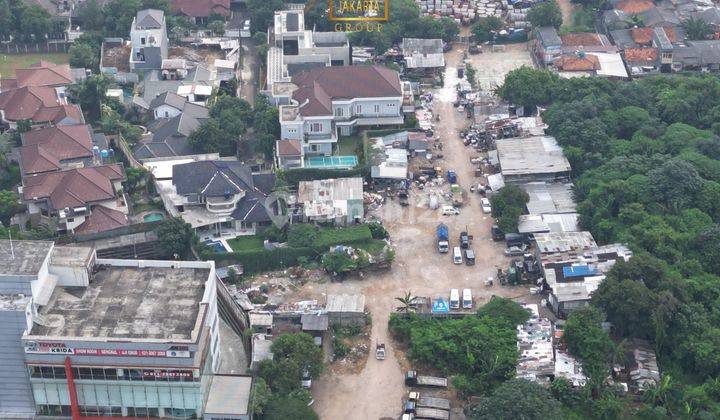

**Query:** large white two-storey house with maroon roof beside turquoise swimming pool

left=280, top=66, right=403, bottom=162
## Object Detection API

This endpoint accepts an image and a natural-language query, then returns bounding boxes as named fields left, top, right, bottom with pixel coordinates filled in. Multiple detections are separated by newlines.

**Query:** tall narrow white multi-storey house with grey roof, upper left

left=130, top=9, right=168, bottom=72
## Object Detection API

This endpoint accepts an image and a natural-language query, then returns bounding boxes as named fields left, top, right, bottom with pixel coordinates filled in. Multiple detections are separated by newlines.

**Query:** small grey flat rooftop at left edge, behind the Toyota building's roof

left=0, top=240, right=53, bottom=276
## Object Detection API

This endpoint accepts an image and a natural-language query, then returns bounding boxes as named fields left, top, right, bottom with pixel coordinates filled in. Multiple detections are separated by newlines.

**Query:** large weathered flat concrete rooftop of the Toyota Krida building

left=30, top=266, right=210, bottom=340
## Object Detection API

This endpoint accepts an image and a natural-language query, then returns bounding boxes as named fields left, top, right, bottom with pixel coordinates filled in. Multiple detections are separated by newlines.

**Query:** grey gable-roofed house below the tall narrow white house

left=133, top=101, right=209, bottom=160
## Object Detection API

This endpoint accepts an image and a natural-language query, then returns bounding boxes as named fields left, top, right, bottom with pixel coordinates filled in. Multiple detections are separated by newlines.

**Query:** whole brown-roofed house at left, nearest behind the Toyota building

left=21, top=164, right=128, bottom=233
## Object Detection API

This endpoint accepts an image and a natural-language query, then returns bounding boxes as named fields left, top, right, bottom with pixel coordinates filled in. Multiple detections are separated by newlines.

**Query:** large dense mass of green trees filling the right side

left=516, top=69, right=720, bottom=418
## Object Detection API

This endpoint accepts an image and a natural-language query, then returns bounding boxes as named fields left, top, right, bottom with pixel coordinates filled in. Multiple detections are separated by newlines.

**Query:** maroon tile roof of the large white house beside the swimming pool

left=292, top=66, right=402, bottom=116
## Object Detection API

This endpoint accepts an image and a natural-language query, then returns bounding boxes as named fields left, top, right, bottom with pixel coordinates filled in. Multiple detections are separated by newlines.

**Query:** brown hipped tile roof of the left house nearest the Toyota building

left=23, top=163, right=125, bottom=210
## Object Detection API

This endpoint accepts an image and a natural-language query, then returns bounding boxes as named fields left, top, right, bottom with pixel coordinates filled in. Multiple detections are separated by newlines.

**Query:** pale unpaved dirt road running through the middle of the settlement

left=302, top=43, right=531, bottom=420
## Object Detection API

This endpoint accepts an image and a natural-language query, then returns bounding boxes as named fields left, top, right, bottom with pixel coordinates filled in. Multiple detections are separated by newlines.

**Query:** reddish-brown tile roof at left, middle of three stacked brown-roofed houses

left=20, top=124, right=92, bottom=174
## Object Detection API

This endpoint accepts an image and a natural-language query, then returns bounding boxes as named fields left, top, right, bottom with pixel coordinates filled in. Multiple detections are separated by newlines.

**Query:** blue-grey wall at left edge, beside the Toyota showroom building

left=0, top=306, right=35, bottom=418
